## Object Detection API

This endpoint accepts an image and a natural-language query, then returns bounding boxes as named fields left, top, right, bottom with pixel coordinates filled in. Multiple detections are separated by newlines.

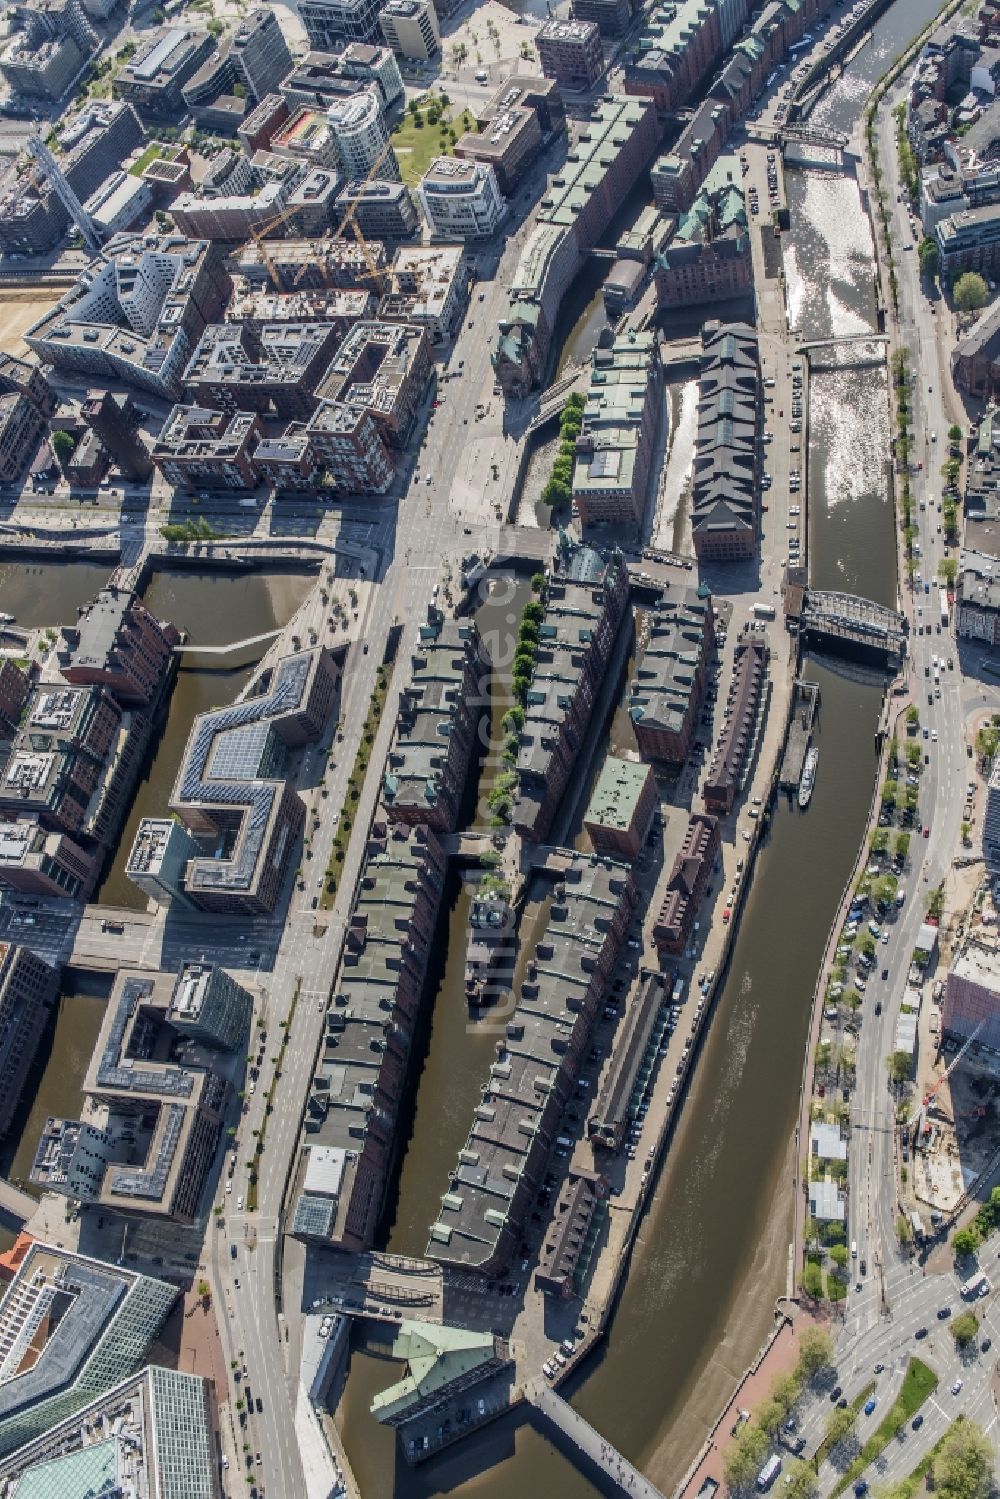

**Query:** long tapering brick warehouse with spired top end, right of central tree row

left=513, top=547, right=628, bottom=841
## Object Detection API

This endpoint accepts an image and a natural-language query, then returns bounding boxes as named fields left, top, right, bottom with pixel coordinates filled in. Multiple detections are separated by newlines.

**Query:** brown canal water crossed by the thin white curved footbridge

left=94, top=571, right=313, bottom=910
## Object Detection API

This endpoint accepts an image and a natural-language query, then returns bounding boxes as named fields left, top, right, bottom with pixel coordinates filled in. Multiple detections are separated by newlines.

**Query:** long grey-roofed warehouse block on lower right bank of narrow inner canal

left=427, top=853, right=636, bottom=1276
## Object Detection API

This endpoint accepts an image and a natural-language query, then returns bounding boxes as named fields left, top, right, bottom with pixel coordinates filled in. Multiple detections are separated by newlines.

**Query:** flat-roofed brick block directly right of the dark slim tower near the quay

left=153, top=406, right=264, bottom=493
